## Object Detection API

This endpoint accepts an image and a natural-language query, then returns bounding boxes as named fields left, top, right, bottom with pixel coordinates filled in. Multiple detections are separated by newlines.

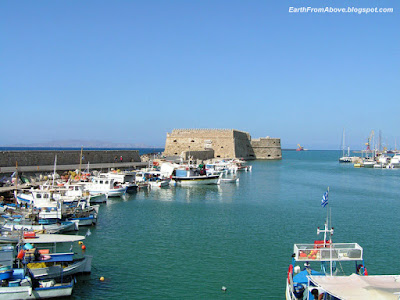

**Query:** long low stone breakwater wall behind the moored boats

left=0, top=150, right=141, bottom=167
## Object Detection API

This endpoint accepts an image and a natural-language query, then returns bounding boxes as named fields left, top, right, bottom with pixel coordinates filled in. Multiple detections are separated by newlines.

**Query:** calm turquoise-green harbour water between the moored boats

left=73, top=151, right=400, bottom=299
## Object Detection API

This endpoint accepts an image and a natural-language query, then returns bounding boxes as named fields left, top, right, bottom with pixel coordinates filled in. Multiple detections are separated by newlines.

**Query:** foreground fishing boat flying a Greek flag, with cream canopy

left=286, top=192, right=400, bottom=300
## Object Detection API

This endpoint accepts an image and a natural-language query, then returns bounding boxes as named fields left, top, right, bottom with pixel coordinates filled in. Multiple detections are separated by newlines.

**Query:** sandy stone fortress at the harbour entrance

left=164, top=129, right=282, bottom=160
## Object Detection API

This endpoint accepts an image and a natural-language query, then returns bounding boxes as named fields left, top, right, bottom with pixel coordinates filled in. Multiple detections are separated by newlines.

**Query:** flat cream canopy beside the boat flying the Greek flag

left=309, top=274, right=400, bottom=300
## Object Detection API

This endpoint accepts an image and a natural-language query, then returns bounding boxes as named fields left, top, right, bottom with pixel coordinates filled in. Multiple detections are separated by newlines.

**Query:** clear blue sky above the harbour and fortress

left=0, top=0, right=400, bottom=149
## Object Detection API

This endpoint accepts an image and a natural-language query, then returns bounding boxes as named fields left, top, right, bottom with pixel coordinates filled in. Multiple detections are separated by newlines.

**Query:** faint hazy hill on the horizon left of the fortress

left=6, top=140, right=160, bottom=148
